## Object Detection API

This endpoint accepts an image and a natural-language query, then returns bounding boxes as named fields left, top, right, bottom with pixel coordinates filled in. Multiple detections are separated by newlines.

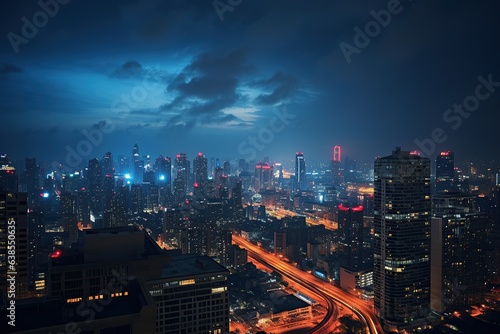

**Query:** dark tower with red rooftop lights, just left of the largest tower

left=338, top=204, right=366, bottom=270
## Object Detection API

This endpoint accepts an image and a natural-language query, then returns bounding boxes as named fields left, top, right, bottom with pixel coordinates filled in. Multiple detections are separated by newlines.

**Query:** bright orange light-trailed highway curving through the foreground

left=233, top=233, right=384, bottom=334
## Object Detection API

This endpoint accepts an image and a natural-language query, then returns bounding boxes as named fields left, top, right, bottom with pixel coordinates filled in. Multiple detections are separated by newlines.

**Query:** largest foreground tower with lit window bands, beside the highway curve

left=373, top=147, right=431, bottom=331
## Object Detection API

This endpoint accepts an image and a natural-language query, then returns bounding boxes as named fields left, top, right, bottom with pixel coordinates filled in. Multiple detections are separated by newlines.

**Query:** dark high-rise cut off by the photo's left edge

left=0, top=192, right=29, bottom=305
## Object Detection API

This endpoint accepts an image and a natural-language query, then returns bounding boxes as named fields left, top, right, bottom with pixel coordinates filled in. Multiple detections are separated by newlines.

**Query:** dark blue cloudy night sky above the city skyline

left=0, top=0, right=500, bottom=164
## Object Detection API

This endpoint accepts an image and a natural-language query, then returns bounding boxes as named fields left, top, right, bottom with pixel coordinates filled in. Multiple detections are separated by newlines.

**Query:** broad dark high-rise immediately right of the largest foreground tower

left=431, top=193, right=489, bottom=312
